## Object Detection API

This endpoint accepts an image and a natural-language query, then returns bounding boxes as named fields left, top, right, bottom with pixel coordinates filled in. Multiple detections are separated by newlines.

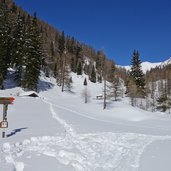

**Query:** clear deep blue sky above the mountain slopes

left=14, top=0, right=171, bottom=65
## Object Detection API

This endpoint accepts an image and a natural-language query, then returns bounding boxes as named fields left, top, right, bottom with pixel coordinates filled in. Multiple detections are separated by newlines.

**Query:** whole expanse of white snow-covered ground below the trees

left=0, top=75, right=171, bottom=171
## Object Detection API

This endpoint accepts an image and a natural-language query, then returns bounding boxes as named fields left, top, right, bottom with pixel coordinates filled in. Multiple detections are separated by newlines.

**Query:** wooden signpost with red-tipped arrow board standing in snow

left=0, top=97, right=15, bottom=138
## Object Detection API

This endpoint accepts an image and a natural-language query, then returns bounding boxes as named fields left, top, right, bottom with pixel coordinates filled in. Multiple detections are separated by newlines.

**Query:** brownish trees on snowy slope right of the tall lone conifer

left=146, top=64, right=171, bottom=113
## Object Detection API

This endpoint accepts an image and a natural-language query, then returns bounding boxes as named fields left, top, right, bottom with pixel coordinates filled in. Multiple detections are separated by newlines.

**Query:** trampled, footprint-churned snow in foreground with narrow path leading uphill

left=1, top=98, right=171, bottom=171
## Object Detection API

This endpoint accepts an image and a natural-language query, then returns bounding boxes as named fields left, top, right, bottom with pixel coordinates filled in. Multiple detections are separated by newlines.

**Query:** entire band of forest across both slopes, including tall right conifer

left=0, top=0, right=171, bottom=111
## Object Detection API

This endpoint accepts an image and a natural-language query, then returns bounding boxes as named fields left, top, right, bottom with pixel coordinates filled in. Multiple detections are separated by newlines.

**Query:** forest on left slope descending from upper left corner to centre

left=0, top=0, right=114, bottom=91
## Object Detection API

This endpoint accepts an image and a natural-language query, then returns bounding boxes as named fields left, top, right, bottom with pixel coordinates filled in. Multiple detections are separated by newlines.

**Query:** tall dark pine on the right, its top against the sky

left=130, top=50, right=145, bottom=97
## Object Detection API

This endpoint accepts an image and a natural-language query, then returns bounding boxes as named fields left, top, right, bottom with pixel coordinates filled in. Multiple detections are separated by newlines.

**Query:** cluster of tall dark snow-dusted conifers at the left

left=0, top=0, right=43, bottom=90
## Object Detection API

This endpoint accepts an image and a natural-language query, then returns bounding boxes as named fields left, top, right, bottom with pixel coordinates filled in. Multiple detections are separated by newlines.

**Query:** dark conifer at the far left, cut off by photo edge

left=0, top=1, right=11, bottom=89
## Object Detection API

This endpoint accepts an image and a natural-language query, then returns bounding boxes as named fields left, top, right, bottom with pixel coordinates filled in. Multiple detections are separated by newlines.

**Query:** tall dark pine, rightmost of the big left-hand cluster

left=22, top=14, right=42, bottom=91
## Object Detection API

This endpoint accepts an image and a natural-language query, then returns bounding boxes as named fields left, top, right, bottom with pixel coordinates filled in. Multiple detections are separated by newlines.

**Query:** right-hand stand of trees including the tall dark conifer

left=122, top=50, right=171, bottom=113
